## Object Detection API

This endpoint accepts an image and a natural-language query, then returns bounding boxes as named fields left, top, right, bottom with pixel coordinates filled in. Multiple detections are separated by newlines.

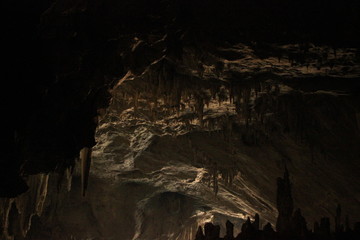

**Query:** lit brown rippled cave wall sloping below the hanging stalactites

left=18, top=69, right=359, bottom=239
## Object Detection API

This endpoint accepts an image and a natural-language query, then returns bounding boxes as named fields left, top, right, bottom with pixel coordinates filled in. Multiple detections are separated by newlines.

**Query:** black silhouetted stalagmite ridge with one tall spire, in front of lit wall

left=195, top=168, right=360, bottom=240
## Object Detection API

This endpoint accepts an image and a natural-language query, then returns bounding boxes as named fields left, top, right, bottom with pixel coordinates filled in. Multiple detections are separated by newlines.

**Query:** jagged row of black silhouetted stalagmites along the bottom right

left=195, top=168, right=360, bottom=240
